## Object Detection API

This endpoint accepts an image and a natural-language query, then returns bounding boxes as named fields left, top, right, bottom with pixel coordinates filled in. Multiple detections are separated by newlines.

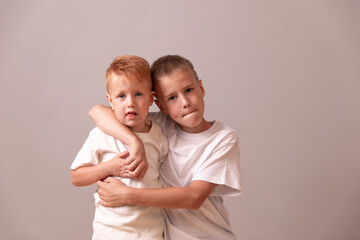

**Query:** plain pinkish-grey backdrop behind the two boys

left=0, top=0, right=360, bottom=240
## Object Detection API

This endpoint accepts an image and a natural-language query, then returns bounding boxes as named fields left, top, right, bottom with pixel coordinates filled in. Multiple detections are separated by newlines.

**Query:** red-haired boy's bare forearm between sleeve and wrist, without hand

left=71, top=163, right=110, bottom=186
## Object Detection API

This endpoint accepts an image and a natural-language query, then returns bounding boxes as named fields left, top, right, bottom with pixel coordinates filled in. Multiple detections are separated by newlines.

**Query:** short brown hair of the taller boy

left=151, top=55, right=199, bottom=87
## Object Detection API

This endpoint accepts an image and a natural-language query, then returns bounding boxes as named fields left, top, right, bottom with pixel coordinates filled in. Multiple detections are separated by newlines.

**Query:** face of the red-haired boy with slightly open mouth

left=106, top=74, right=154, bottom=132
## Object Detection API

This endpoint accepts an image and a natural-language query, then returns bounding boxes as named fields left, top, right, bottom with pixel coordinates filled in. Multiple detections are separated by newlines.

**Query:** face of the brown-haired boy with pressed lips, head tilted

left=155, top=69, right=208, bottom=133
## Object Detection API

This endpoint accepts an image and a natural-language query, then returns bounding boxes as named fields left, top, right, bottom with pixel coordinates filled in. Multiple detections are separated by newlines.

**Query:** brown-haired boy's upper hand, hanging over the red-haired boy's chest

left=126, top=139, right=149, bottom=180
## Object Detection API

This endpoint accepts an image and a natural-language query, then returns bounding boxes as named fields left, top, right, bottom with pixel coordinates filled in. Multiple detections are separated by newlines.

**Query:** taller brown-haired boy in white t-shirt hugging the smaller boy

left=89, top=55, right=240, bottom=240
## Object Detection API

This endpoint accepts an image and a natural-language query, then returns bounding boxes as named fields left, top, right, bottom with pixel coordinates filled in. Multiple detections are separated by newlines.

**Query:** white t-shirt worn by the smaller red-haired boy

left=71, top=120, right=168, bottom=240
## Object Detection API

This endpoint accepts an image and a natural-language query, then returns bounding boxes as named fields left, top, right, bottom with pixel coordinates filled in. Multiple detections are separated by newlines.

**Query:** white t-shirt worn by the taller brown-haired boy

left=149, top=113, right=240, bottom=240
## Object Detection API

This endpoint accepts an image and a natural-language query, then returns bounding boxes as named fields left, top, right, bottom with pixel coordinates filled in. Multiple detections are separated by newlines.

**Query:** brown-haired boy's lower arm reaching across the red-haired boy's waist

left=97, top=177, right=216, bottom=209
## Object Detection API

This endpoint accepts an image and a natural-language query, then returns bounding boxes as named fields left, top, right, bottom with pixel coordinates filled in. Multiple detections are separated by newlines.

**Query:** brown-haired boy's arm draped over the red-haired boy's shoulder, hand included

left=89, top=105, right=148, bottom=179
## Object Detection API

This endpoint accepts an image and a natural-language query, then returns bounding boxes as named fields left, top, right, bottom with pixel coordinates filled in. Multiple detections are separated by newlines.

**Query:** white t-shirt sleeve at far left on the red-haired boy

left=70, top=129, right=99, bottom=170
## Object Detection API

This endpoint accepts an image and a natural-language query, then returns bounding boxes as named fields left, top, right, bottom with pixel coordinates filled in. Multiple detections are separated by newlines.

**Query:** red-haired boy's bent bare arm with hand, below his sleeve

left=71, top=152, right=129, bottom=186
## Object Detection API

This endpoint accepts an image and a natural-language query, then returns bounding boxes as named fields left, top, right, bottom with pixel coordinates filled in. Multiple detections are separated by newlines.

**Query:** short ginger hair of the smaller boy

left=106, top=55, right=152, bottom=92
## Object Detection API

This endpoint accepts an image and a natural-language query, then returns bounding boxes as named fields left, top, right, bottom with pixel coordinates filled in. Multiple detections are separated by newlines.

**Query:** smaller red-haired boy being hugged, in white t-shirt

left=71, top=56, right=168, bottom=240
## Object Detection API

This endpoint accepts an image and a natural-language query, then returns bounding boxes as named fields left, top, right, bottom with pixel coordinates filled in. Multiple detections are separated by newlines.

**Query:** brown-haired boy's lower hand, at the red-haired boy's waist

left=97, top=177, right=128, bottom=207
